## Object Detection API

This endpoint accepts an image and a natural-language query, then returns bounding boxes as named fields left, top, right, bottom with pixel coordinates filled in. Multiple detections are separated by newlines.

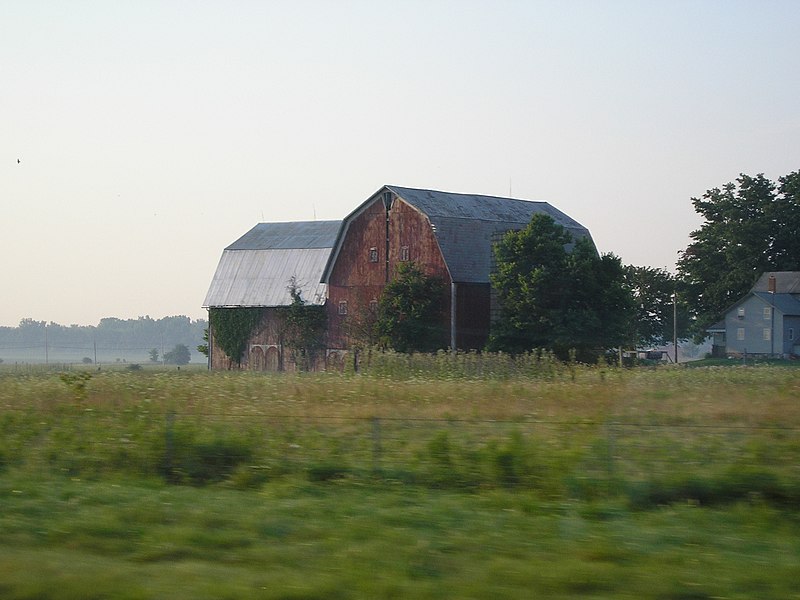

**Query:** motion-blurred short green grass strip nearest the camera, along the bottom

left=0, top=473, right=800, bottom=599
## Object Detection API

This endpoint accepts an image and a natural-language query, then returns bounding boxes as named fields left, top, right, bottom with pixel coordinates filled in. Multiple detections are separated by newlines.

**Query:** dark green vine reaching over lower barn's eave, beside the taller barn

left=283, top=280, right=327, bottom=371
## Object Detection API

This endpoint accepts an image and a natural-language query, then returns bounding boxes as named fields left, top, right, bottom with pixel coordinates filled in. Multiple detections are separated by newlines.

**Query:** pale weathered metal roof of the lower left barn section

left=203, top=221, right=341, bottom=307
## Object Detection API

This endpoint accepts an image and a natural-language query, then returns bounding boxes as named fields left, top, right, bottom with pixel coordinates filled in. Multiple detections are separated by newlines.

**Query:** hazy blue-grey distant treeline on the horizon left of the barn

left=0, top=315, right=208, bottom=363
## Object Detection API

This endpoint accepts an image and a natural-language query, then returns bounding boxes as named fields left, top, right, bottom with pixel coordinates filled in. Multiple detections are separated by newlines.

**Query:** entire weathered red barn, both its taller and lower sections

left=204, top=185, right=590, bottom=370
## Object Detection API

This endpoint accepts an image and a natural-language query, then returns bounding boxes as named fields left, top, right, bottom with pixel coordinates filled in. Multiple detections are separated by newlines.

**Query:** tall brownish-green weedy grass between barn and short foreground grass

left=0, top=364, right=800, bottom=506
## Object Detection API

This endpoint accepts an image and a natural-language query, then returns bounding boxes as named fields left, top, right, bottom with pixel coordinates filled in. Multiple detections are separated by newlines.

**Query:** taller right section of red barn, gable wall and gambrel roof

left=322, top=185, right=590, bottom=349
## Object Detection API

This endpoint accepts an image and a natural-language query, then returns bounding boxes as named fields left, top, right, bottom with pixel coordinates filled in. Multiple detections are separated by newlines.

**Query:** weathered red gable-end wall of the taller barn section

left=328, top=197, right=451, bottom=348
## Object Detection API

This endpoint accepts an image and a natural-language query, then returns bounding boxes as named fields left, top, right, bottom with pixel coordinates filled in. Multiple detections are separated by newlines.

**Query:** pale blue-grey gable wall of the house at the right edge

left=725, top=296, right=783, bottom=355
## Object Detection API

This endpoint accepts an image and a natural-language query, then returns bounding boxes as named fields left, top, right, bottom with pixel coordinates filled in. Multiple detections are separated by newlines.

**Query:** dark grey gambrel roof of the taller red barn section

left=323, top=185, right=591, bottom=283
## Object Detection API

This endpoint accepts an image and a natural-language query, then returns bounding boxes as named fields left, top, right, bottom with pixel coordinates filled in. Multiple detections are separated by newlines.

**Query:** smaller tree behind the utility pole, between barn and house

left=625, top=265, right=690, bottom=347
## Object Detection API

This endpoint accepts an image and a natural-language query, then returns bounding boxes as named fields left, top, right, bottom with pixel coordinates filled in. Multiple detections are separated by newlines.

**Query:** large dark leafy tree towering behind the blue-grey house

left=678, top=171, right=800, bottom=337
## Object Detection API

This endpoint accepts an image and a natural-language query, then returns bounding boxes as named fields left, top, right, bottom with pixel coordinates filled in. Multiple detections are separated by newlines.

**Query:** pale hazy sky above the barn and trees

left=0, top=0, right=800, bottom=326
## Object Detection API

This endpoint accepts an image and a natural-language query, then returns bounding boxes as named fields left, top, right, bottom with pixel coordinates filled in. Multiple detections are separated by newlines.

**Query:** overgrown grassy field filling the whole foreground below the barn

left=0, top=367, right=800, bottom=599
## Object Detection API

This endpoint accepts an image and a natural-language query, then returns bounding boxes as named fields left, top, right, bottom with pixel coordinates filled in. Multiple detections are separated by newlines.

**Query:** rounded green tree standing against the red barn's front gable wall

left=375, top=262, right=447, bottom=352
